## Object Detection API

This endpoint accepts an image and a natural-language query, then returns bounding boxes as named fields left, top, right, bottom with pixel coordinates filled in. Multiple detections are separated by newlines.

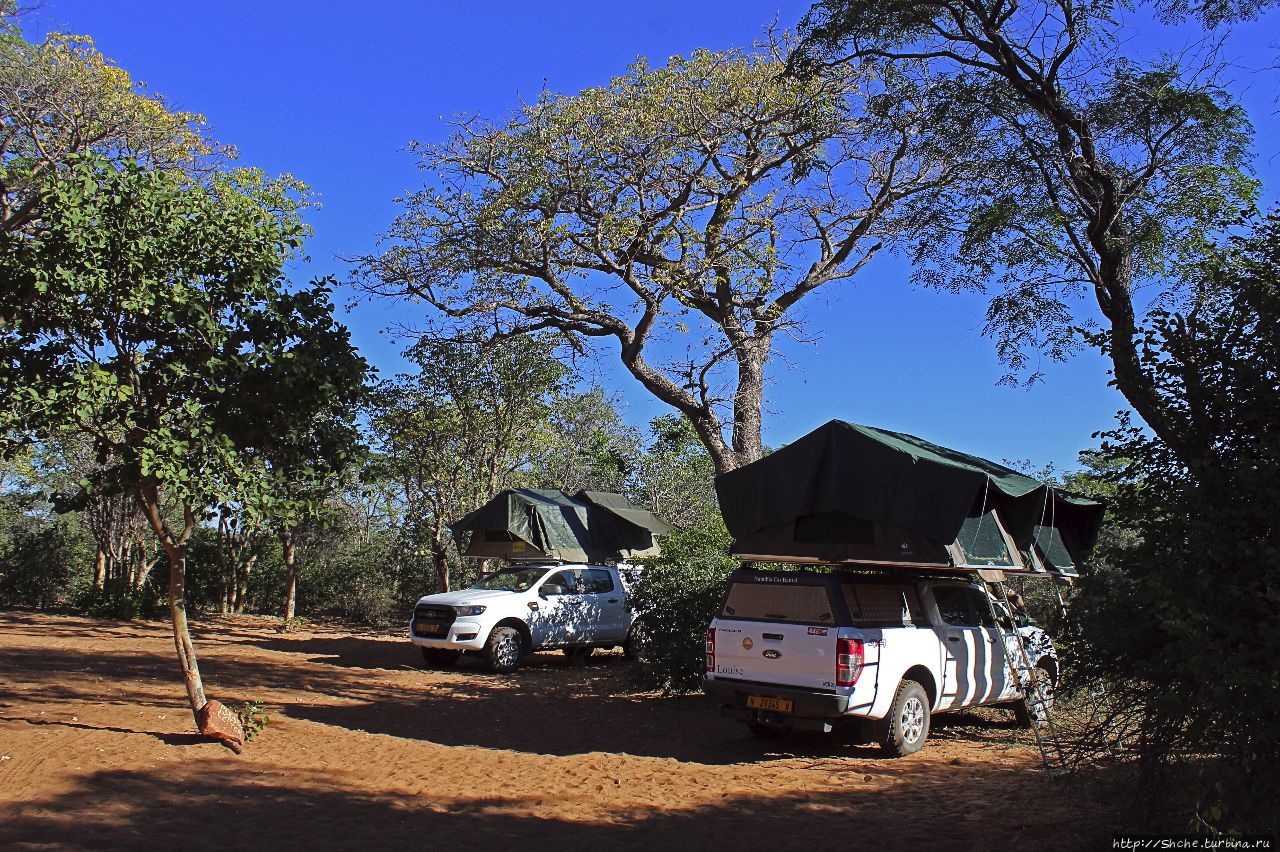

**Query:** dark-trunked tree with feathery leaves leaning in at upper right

left=792, top=0, right=1257, bottom=466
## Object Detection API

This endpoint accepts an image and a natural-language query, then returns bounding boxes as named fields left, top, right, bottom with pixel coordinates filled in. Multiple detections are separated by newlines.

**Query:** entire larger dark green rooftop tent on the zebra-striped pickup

left=716, top=420, right=1103, bottom=577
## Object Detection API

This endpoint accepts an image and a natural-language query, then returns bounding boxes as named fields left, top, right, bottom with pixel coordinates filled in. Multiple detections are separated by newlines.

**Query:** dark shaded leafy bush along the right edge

left=1073, top=208, right=1280, bottom=832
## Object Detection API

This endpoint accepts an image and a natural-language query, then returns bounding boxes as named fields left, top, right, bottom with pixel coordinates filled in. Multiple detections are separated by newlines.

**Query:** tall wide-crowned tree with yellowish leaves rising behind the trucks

left=361, top=43, right=959, bottom=471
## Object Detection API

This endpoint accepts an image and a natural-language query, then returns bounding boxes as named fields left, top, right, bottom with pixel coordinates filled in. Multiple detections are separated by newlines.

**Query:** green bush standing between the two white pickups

left=628, top=516, right=737, bottom=693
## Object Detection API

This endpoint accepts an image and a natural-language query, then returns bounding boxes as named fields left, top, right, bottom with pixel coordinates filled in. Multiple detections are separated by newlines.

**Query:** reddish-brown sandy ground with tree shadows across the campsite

left=0, top=613, right=1114, bottom=852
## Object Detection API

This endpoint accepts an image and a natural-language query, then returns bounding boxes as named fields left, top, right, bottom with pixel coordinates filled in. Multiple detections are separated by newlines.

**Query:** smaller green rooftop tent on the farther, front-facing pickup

left=449, top=489, right=675, bottom=563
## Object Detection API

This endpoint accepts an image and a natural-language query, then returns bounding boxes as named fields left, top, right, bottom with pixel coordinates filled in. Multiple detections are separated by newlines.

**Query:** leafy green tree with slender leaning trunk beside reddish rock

left=0, top=156, right=365, bottom=736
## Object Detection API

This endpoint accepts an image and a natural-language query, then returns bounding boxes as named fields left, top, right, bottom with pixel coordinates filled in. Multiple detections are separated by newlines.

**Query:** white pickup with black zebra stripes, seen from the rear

left=703, top=569, right=1057, bottom=756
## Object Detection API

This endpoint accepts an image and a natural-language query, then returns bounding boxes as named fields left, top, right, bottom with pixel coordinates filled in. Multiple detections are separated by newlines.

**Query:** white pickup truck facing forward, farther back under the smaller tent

left=408, top=563, right=637, bottom=673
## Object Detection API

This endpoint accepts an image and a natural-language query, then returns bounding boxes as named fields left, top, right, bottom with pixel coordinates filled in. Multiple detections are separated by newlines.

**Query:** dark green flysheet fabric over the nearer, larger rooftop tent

left=716, top=420, right=1102, bottom=563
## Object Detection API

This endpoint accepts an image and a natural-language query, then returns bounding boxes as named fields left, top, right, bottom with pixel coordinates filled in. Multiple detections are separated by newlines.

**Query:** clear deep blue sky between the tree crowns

left=27, top=0, right=1280, bottom=469
